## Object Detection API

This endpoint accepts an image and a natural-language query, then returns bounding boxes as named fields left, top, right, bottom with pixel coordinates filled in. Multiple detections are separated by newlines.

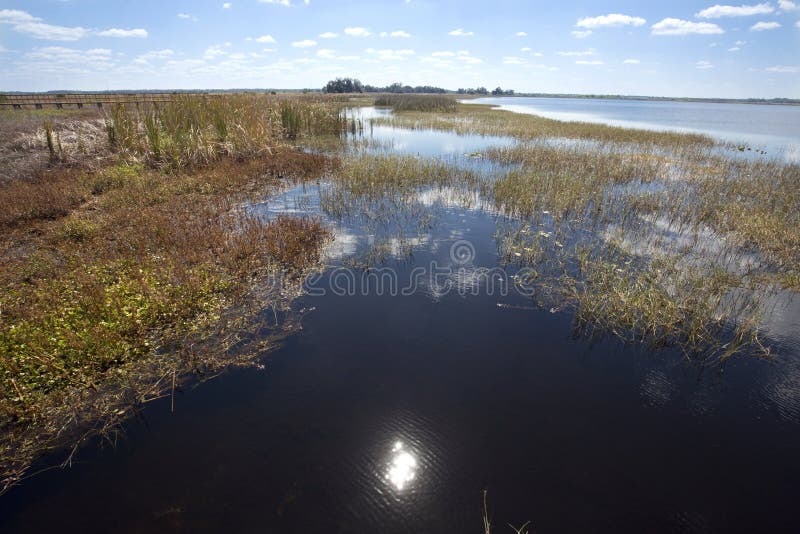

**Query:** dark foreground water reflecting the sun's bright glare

left=0, top=115, right=800, bottom=533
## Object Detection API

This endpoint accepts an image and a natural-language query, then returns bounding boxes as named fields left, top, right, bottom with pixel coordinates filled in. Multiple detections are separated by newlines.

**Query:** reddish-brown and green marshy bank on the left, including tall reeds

left=0, top=96, right=341, bottom=490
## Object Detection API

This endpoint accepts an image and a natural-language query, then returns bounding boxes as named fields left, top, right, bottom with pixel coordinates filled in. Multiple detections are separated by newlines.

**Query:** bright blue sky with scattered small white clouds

left=0, top=0, right=800, bottom=98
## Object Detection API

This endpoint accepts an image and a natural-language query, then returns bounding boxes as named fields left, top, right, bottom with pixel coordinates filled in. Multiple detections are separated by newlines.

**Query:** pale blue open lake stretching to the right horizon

left=464, top=97, right=800, bottom=162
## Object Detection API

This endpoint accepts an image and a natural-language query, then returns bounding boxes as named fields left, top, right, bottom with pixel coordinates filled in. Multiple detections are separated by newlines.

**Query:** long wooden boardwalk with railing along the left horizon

left=0, top=93, right=221, bottom=109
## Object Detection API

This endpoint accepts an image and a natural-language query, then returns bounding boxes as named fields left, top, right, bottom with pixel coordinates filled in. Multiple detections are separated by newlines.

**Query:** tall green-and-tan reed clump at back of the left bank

left=101, top=94, right=347, bottom=169
